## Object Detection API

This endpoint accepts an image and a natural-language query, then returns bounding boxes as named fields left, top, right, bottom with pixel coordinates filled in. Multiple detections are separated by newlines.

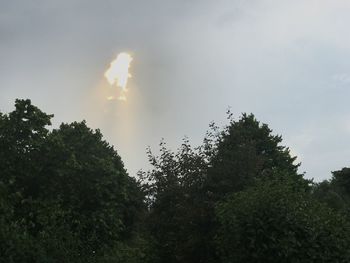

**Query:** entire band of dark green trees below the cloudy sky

left=0, top=100, right=350, bottom=263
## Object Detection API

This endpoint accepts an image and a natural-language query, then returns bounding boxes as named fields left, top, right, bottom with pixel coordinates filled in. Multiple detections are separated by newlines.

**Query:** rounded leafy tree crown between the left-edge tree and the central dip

left=37, top=122, right=132, bottom=250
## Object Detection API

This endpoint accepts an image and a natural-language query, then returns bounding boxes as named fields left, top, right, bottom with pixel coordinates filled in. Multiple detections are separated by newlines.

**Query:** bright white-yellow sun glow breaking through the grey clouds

left=104, top=52, right=133, bottom=101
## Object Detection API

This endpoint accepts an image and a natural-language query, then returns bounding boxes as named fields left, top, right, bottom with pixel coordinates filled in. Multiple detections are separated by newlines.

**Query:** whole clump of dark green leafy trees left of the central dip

left=0, top=100, right=144, bottom=262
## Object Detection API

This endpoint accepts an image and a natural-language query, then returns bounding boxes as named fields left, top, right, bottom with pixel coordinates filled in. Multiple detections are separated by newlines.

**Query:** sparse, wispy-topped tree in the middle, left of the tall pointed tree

left=139, top=139, right=212, bottom=262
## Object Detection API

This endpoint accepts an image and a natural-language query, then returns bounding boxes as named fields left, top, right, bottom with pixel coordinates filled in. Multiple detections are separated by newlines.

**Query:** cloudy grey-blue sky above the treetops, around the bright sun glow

left=0, top=0, right=350, bottom=181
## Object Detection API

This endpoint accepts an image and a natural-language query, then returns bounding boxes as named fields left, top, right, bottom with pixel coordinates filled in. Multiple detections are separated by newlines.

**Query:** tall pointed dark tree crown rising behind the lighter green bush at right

left=207, top=114, right=307, bottom=200
